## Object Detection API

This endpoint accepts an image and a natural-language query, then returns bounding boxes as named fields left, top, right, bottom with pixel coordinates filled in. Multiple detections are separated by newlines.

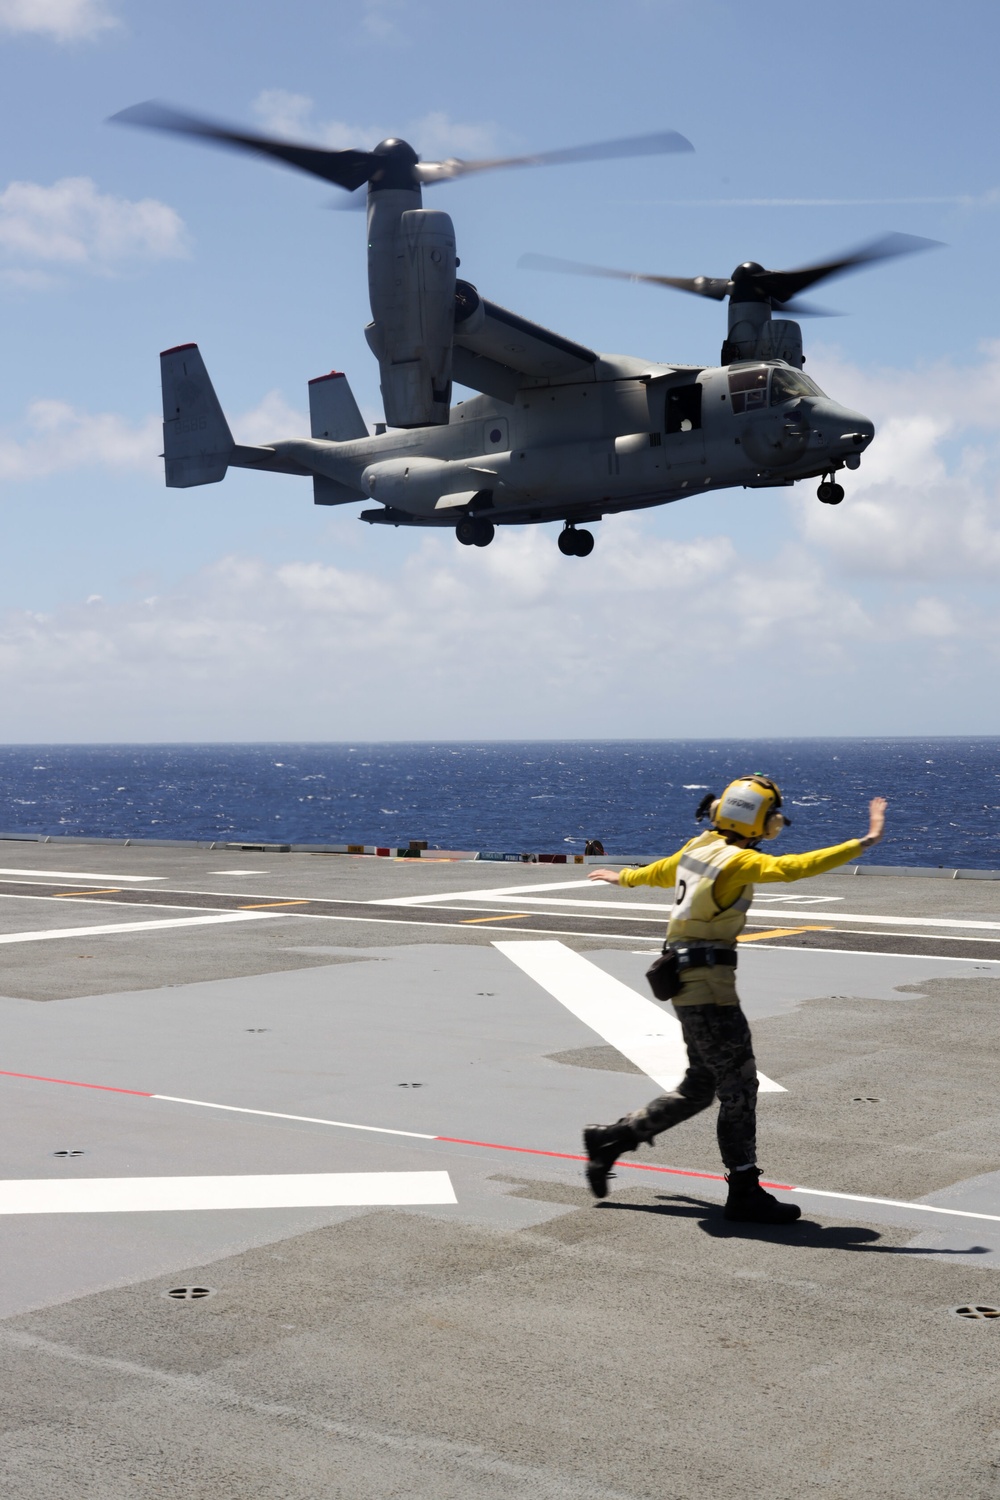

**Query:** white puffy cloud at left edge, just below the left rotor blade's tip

left=0, top=177, right=187, bottom=275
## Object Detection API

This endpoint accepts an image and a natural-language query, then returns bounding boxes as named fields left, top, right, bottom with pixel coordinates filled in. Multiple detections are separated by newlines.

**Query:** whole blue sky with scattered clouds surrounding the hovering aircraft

left=0, top=0, right=1000, bottom=741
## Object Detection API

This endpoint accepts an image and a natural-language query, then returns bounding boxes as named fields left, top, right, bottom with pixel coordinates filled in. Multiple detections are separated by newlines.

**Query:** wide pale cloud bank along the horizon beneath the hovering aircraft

left=0, top=509, right=1000, bottom=741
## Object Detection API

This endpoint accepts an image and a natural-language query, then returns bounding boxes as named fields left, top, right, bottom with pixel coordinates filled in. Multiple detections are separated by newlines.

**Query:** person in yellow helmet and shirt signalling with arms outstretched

left=583, top=774, right=886, bottom=1224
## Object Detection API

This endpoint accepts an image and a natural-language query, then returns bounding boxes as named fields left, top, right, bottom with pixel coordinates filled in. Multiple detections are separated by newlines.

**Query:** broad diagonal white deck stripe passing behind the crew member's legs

left=493, top=942, right=786, bottom=1094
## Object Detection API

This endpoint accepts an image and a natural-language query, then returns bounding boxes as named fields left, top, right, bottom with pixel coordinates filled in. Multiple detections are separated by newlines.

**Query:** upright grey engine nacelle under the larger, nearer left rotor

left=364, top=205, right=456, bottom=428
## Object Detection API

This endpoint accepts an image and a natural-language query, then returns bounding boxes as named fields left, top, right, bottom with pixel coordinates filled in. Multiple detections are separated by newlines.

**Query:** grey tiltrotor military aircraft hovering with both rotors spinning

left=115, top=104, right=933, bottom=557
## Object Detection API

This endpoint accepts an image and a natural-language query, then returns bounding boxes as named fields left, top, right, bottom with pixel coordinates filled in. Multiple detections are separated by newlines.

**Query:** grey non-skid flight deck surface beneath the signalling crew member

left=0, top=845, right=1000, bottom=1500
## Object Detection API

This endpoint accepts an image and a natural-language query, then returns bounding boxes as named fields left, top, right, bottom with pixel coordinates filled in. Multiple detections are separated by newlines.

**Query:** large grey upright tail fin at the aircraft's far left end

left=160, top=344, right=235, bottom=489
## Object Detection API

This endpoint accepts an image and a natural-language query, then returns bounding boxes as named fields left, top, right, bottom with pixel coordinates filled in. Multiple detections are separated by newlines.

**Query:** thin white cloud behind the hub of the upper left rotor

left=253, top=89, right=501, bottom=161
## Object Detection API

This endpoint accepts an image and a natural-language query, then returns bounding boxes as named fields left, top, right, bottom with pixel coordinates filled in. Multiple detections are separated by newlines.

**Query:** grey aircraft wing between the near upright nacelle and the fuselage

left=453, top=282, right=598, bottom=402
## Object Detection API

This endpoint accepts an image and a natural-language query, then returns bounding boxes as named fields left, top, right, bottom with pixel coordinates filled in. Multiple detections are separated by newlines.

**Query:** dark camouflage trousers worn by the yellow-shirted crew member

left=625, top=1005, right=757, bottom=1172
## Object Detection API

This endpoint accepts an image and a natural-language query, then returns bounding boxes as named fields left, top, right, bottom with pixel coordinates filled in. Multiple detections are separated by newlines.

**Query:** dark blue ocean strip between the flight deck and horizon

left=0, top=738, right=1000, bottom=869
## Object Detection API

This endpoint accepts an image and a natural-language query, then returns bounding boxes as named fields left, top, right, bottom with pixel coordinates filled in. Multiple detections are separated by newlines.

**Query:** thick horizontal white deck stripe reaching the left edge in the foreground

left=0, top=1172, right=457, bottom=1214
